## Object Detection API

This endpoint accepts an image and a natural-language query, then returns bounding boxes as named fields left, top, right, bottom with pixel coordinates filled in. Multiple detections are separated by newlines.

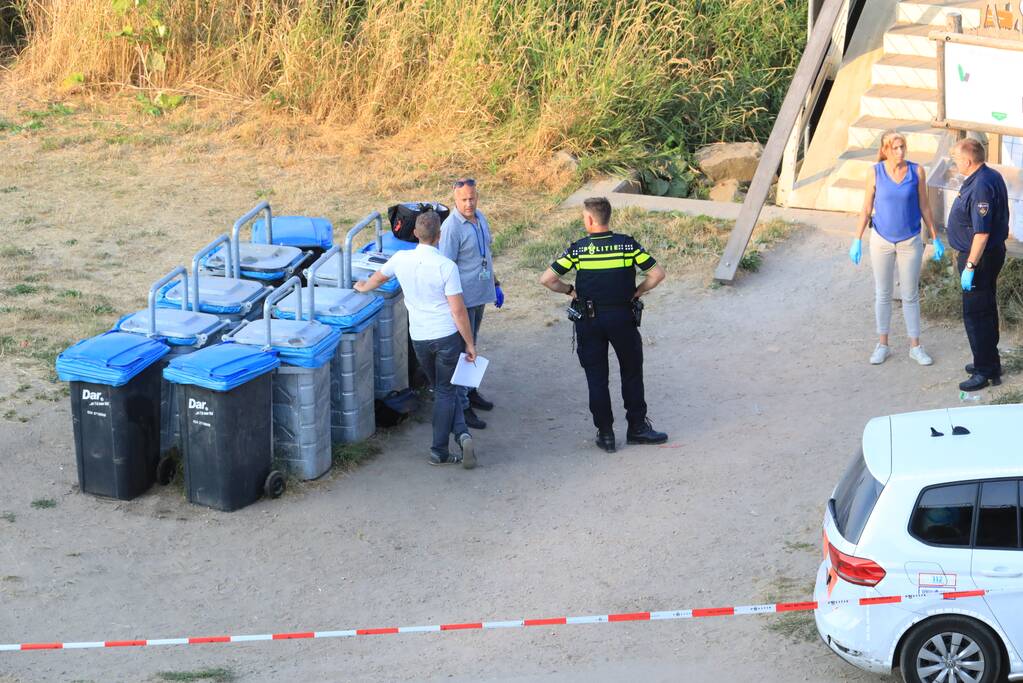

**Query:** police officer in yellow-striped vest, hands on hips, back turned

left=540, top=197, right=668, bottom=453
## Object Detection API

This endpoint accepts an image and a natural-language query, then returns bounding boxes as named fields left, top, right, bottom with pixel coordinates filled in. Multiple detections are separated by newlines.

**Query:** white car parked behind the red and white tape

left=814, top=405, right=1023, bottom=683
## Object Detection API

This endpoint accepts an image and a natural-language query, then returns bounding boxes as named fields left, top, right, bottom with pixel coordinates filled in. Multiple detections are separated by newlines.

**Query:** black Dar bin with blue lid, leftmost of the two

left=56, top=331, right=170, bottom=500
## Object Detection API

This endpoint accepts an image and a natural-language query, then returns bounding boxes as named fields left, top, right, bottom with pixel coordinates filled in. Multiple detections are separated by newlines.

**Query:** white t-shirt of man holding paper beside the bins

left=380, top=244, right=461, bottom=342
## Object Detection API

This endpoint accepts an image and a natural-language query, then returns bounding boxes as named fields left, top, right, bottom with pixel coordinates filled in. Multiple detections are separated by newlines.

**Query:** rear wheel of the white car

left=899, top=617, right=1002, bottom=683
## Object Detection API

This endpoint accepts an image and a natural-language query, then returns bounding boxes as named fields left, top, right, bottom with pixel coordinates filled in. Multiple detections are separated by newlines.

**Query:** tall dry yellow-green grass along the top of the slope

left=6, top=0, right=806, bottom=166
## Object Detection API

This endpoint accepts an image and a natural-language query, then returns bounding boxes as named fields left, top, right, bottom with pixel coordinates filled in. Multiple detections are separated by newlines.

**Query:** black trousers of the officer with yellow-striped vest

left=576, top=307, right=647, bottom=431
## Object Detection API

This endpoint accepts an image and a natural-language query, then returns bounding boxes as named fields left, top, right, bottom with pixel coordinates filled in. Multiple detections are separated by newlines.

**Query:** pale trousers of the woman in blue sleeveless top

left=871, top=230, right=924, bottom=338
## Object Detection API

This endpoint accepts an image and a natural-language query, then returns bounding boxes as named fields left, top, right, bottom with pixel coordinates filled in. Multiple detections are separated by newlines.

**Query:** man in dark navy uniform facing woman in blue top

left=947, top=138, right=1009, bottom=392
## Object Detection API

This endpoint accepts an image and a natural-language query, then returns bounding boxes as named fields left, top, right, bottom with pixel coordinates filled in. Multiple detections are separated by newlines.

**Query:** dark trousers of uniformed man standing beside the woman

left=958, top=246, right=1006, bottom=377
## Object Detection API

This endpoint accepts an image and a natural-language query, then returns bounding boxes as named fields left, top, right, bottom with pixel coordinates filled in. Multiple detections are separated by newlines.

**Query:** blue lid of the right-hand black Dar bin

left=164, top=343, right=280, bottom=392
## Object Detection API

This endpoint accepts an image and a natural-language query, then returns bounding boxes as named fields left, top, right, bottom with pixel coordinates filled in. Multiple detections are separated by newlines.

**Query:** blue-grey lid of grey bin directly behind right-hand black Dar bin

left=230, top=318, right=341, bottom=368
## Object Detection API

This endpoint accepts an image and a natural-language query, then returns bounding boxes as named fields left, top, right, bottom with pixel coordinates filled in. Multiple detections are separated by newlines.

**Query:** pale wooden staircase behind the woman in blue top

left=815, top=0, right=981, bottom=212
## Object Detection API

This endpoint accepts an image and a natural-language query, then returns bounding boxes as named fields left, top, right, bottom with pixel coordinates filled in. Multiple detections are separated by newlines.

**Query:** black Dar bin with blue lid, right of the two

left=164, top=343, right=284, bottom=512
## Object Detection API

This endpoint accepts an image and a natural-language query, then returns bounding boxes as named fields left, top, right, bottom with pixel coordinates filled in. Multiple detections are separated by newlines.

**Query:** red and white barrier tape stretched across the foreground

left=0, top=590, right=990, bottom=652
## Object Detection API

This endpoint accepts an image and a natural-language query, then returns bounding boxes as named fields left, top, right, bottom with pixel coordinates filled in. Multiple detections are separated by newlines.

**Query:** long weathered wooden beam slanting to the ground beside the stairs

left=714, top=0, right=846, bottom=283
